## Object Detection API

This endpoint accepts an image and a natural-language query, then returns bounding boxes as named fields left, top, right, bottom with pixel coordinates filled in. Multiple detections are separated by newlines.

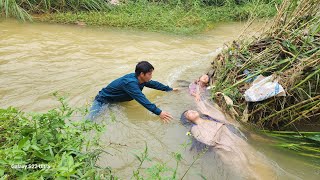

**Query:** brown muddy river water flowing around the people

left=0, top=20, right=320, bottom=180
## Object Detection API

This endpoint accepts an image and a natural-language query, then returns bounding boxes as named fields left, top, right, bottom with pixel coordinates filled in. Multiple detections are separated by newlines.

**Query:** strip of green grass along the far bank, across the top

left=0, top=0, right=276, bottom=34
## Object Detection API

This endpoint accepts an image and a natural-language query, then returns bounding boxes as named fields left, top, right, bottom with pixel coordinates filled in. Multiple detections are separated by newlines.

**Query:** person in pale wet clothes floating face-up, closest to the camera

left=180, top=110, right=275, bottom=179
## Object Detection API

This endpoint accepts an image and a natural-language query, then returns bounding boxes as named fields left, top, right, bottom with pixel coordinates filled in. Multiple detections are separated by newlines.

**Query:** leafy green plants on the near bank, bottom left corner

left=0, top=93, right=113, bottom=179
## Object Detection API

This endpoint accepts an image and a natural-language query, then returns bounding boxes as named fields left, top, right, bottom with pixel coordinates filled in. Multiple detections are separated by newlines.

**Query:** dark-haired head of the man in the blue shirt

left=135, top=61, right=154, bottom=83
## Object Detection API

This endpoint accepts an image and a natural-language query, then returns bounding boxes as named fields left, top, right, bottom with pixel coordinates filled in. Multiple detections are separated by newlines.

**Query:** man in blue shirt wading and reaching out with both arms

left=89, top=61, right=177, bottom=122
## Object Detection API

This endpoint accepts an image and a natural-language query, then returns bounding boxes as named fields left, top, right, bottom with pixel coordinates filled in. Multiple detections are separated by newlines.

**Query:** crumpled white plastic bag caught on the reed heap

left=244, top=75, right=286, bottom=102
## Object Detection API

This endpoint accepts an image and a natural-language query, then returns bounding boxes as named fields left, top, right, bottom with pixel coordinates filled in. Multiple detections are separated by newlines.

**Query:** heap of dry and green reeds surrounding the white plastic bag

left=212, top=0, right=320, bottom=130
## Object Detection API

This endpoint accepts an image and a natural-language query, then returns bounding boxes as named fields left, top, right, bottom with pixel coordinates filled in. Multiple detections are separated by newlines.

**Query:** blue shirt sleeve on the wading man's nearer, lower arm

left=123, top=82, right=161, bottom=115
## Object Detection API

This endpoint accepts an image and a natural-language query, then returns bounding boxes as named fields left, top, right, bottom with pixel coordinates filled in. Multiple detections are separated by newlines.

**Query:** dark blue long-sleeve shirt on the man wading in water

left=96, top=73, right=172, bottom=115
